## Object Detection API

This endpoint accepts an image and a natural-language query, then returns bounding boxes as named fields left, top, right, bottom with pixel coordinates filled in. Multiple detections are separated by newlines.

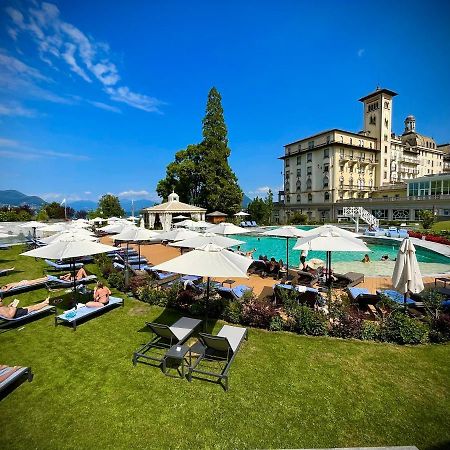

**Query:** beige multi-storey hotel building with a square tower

left=275, top=88, right=450, bottom=223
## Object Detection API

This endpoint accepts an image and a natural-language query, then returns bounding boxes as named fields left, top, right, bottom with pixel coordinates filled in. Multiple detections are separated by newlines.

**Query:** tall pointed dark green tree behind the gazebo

left=156, top=87, right=243, bottom=214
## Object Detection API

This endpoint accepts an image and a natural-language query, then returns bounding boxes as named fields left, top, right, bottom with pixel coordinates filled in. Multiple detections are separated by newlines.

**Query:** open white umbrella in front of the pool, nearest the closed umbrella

left=293, top=230, right=371, bottom=284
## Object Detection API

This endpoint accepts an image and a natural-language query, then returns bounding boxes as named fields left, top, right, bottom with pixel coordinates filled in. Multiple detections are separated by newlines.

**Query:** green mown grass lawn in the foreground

left=0, top=248, right=450, bottom=450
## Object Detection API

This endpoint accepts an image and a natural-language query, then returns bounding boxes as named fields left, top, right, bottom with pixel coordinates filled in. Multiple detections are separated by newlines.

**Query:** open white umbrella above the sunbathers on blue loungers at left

left=22, top=236, right=115, bottom=303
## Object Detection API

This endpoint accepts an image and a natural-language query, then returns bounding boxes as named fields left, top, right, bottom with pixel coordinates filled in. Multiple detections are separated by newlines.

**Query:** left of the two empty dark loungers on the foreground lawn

left=133, top=317, right=202, bottom=365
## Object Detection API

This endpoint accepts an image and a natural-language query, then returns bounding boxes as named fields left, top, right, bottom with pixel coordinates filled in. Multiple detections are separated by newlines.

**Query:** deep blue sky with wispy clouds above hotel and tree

left=0, top=0, right=450, bottom=204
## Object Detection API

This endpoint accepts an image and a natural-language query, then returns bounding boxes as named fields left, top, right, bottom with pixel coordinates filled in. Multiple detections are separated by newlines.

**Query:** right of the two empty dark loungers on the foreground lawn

left=188, top=325, right=248, bottom=391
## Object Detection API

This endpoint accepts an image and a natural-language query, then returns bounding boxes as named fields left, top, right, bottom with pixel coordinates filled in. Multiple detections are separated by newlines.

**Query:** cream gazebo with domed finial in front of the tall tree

left=142, top=192, right=206, bottom=231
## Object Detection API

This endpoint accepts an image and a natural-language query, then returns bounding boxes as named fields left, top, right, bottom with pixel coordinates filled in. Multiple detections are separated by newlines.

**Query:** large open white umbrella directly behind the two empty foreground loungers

left=154, top=244, right=253, bottom=328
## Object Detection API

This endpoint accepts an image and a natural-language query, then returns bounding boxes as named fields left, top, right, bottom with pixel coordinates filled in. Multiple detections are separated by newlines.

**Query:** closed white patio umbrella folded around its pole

left=392, top=238, right=425, bottom=305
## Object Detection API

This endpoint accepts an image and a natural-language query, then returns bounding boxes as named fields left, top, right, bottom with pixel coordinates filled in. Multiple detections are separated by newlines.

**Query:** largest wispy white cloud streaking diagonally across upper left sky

left=6, top=2, right=163, bottom=112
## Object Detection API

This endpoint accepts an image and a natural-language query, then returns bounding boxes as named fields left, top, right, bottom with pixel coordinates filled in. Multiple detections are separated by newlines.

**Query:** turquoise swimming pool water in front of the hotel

left=233, top=232, right=450, bottom=275
